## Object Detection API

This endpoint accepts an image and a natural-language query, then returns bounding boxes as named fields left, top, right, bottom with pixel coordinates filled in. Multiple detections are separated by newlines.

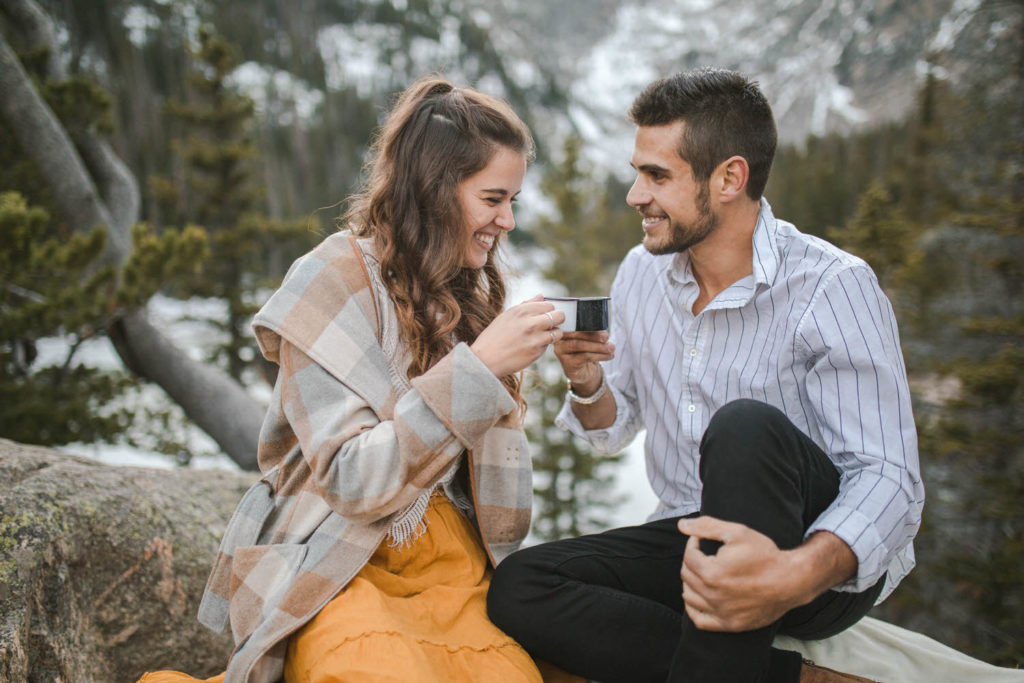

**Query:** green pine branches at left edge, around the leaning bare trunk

left=0, top=31, right=206, bottom=445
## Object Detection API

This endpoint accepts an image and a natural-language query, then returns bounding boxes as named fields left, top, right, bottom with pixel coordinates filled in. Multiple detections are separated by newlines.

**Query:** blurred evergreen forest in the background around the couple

left=0, top=0, right=1024, bottom=666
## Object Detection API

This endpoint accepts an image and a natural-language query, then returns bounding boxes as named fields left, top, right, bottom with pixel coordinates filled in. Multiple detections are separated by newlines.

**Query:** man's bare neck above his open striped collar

left=689, top=202, right=761, bottom=315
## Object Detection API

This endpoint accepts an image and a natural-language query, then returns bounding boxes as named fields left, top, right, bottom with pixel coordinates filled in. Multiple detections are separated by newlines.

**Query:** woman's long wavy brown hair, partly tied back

left=342, top=77, right=534, bottom=412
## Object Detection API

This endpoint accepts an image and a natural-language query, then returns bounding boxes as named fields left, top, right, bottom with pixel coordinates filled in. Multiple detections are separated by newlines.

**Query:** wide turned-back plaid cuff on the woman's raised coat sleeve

left=412, top=343, right=516, bottom=450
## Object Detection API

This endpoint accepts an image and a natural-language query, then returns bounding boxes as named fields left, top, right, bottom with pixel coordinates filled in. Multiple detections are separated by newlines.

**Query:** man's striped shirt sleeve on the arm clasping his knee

left=800, top=267, right=925, bottom=591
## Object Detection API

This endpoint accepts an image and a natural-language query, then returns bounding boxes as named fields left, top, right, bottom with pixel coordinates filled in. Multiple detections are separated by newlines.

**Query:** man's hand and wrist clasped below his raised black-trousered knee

left=679, top=517, right=857, bottom=632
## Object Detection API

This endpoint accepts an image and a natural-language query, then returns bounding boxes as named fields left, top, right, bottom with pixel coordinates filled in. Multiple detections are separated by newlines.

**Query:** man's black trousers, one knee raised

left=487, top=399, right=884, bottom=683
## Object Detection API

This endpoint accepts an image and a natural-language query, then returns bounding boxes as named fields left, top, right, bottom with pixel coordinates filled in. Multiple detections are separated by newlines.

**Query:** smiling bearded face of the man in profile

left=626, top=121, right=718, bottom=254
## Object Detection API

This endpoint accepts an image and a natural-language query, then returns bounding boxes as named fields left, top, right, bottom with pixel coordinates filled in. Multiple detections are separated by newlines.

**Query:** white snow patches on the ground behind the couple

left=48, top=244, right=656, bottom=526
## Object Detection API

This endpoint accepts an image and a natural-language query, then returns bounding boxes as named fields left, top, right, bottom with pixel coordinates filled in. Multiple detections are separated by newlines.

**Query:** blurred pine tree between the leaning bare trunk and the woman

left=150, top=28, right=315, bottom=380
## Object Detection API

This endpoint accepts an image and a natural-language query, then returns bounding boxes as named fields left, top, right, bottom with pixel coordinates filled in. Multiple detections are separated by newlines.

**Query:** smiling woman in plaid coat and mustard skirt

left=143, top=78, right=577, bottom=683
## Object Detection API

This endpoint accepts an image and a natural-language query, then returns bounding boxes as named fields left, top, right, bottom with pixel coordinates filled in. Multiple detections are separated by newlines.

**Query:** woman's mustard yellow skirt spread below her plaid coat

left=140, top=490, right=583, bottom=683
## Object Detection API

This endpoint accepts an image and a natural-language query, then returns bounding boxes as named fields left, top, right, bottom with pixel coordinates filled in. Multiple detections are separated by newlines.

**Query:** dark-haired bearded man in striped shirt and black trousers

left=488, top=65, right=924, bottom=683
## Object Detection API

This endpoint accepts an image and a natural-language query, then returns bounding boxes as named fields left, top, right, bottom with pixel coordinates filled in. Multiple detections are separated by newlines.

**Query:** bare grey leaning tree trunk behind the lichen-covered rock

left=0, top=0, right=262, bottom=469
